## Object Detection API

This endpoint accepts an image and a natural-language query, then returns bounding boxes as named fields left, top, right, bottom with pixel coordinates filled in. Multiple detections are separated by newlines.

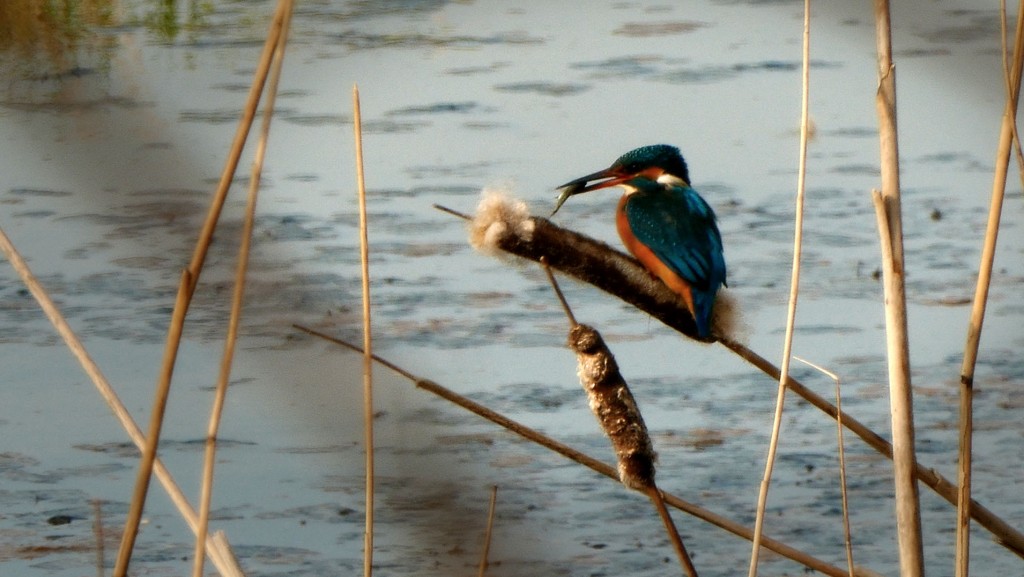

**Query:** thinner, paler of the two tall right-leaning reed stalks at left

left=193, top=0, right=292, bottom=577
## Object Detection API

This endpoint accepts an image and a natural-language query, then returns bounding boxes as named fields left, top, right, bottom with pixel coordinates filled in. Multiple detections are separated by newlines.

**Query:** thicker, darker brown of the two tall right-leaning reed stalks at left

left=114, top=0, right=291, bottom=577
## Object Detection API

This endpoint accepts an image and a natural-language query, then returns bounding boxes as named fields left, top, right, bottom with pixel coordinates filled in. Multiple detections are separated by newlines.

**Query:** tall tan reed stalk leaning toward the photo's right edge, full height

left=955, top=1, right=1024, bottom=577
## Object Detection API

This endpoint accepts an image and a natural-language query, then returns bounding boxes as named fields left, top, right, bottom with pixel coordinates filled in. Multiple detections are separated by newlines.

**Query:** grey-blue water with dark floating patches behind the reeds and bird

left=0, top=1, right=1024, bottom=576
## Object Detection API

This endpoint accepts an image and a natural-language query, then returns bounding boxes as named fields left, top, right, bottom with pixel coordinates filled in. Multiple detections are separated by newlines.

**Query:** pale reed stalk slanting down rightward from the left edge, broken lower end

left=0, top=223, right=242, bottom=577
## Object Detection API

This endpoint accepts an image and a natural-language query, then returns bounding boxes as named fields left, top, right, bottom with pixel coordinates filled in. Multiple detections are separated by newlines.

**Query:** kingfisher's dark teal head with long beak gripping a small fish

left=551, top=145, right=690, bottom=216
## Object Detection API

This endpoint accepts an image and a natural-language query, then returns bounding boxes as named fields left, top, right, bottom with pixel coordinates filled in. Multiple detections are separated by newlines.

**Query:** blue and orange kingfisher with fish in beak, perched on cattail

left=551, top=145, right=727, bottom=339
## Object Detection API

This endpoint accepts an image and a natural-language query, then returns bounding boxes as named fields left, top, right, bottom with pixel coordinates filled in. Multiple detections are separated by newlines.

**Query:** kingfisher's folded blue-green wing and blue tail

left=625, top=178, right=726, bottom=335
